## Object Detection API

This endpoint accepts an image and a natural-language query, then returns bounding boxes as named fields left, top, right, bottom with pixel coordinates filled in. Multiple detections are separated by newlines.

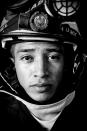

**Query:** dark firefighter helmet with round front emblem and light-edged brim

left=0, top=0, right=87, bottom=100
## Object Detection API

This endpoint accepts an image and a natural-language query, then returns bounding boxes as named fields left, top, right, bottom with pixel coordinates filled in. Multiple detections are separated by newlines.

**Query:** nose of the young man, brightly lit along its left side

left=34, top=57, right=48, bottom=78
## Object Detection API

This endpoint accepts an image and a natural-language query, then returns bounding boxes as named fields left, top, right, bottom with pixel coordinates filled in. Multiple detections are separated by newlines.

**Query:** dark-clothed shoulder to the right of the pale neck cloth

left=53, top=94, right=87, bottom=131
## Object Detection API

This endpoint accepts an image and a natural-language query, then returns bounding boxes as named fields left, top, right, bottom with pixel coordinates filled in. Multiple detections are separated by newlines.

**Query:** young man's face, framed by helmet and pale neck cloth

left=13, top=42, right=64, bottom=102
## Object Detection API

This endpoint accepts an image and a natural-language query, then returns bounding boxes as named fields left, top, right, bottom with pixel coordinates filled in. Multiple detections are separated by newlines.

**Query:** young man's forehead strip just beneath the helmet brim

left=13, top=42, right=61, bottom=53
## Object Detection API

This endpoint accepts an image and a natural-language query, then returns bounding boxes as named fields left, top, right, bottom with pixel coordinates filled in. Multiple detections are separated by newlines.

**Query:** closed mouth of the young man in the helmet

left=32, top=83, right=52, bottom=93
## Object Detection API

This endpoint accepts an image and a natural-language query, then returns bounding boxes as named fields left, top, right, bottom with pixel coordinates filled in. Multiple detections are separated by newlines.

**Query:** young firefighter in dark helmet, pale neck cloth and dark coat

left=0, top=2, right=86, bottom=131
